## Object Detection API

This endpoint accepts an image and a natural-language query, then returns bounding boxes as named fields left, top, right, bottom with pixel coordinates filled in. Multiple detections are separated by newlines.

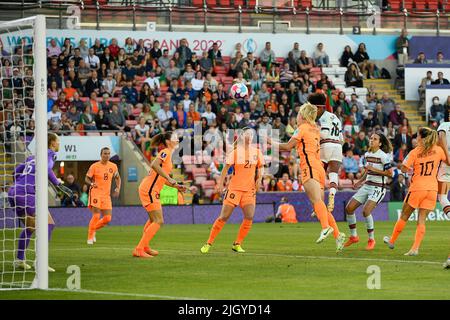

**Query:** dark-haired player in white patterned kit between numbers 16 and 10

left=345, top=132, right=392, bottom=250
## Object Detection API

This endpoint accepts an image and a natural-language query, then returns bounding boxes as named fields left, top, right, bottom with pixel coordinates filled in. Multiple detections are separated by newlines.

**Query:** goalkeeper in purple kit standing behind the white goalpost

left=8, top=133, right=73, bottom=272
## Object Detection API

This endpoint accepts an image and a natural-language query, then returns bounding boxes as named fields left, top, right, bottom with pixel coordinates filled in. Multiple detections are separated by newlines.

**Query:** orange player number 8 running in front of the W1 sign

left=85, top=147, right=121, bottom=245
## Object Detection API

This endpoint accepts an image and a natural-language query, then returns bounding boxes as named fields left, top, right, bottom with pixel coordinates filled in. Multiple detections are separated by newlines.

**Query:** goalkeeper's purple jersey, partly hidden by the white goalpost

left=13, top=149, right=61, bottom=194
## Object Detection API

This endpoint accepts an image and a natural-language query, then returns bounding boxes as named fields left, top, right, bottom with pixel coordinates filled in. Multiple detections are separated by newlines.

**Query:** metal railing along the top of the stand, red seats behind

left=0, top=0, right=450, bottom=35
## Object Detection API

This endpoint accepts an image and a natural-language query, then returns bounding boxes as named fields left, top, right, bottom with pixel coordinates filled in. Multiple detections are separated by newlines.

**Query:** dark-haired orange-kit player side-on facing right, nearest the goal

left=133, top=131, right=186, bottom=258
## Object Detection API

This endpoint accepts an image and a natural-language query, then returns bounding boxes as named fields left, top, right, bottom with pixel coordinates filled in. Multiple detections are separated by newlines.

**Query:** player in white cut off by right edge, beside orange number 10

left=437, top=122, right=450, bottom=269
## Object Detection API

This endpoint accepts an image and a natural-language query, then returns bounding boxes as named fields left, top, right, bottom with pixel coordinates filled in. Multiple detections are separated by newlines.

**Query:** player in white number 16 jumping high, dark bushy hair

left=308, top=93, right=343, bottom=213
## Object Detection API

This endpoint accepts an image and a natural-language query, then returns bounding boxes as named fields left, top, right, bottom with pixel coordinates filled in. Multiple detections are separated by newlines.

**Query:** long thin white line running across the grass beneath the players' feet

left=53, top=247, right=442, bottom=265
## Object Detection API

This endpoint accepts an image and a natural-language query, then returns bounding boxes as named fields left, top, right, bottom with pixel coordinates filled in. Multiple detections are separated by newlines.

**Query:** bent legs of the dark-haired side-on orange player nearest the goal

left=133, top=210, right=164, bottom=258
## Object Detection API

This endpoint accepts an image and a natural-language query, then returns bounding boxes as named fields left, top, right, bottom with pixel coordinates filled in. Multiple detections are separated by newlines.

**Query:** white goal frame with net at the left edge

left=0, top=16, right=48, bottom=290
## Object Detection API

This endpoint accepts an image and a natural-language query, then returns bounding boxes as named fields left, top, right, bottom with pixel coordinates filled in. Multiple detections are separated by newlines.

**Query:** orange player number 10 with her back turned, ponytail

left=383, top=127, right=450, bottom=256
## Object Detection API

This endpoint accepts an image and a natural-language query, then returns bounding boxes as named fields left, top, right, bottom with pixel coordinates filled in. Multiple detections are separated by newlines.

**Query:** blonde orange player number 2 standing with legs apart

left=200, top=127, right=264, bottom=253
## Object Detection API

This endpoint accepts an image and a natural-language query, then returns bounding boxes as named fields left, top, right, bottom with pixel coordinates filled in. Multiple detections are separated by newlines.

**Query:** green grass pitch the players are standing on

left=0, top=222, right=450, bottom=300
